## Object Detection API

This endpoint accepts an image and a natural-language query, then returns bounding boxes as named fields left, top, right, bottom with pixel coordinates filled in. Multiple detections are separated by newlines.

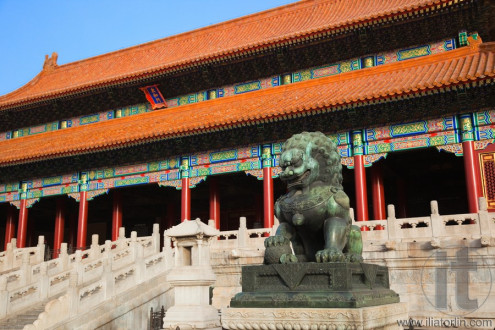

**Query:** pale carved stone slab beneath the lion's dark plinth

left=222, top=303, right=408, bottom=330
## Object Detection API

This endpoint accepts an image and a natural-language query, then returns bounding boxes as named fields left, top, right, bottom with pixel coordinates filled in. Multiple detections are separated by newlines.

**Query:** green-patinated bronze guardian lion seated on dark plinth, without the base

left=265, top=132, right=362, bottom=264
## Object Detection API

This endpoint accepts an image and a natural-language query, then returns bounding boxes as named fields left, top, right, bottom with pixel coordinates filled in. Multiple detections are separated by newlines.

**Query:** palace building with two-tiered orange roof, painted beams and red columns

left=0, top=0, right=495, bottom=257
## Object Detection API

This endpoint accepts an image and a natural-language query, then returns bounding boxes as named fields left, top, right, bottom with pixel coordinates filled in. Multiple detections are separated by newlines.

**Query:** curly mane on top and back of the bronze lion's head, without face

left=282, top=132, right=342, bottom=189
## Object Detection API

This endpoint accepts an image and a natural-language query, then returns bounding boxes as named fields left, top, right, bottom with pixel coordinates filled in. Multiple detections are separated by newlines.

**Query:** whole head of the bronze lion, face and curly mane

left=280, top=132, right=342, bottom=190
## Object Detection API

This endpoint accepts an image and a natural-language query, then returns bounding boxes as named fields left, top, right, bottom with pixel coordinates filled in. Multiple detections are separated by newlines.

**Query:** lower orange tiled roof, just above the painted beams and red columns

left=0, top=43, right=495, bottom=166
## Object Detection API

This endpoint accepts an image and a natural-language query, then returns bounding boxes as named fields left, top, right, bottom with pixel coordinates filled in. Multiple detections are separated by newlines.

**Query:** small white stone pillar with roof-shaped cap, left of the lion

left=163, top=219, right=221, bottom=330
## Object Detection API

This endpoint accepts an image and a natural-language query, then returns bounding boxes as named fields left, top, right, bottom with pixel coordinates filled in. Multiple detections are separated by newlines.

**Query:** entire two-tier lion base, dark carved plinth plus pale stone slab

left=222, top=263, right=408, bottom=330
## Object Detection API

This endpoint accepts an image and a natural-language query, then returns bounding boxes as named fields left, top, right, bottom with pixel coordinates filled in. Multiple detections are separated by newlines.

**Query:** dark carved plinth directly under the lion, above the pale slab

left=230, top=263, right=399, bottom=309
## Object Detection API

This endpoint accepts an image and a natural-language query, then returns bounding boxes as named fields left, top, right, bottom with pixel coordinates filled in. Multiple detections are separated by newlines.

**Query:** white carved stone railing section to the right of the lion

left=353, top=197, right=495, bottom=248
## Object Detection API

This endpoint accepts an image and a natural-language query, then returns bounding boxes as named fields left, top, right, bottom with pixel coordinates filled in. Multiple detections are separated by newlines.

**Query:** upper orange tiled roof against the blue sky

left=0, top=0, right=464, bottom=110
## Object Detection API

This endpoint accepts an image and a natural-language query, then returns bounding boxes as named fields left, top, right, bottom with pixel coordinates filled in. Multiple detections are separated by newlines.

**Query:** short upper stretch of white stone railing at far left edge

left=0, top=236, right=45, bottom=274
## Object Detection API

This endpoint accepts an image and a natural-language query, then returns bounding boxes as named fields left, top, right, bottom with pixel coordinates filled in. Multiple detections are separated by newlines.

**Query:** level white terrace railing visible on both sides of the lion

left=207, top=197, right=495, bottom=258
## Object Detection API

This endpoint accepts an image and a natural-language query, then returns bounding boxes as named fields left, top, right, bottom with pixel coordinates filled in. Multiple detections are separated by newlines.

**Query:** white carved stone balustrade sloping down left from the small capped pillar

left=24, top=224, right=173, bottom=330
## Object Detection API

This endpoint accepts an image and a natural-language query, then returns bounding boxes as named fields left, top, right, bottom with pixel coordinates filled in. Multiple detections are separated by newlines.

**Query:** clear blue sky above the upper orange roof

left=0, top=0, right=296, bottom=95
